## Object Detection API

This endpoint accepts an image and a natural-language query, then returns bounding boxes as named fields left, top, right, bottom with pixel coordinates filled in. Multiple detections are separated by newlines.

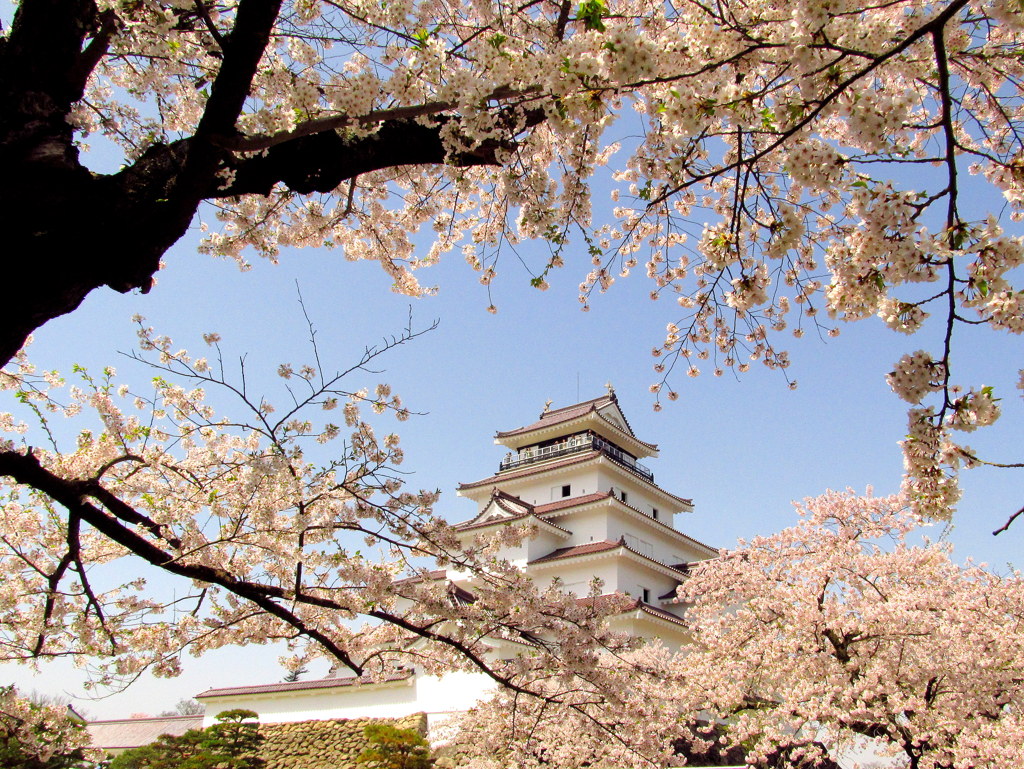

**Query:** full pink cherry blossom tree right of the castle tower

left=680, top=493, right=1024, bottom=769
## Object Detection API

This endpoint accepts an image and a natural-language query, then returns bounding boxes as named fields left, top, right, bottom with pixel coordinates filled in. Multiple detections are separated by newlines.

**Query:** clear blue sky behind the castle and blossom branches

left=4, top=207, right=1024, bottom=717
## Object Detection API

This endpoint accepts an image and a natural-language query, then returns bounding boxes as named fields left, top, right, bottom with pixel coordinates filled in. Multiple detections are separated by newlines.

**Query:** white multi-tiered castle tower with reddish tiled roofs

left=451, top=387, right=718, bottom=646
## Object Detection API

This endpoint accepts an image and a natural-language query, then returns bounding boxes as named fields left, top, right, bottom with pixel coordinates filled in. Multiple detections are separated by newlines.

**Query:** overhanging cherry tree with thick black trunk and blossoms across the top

left=0, top=0, right=1024, bottom=528
